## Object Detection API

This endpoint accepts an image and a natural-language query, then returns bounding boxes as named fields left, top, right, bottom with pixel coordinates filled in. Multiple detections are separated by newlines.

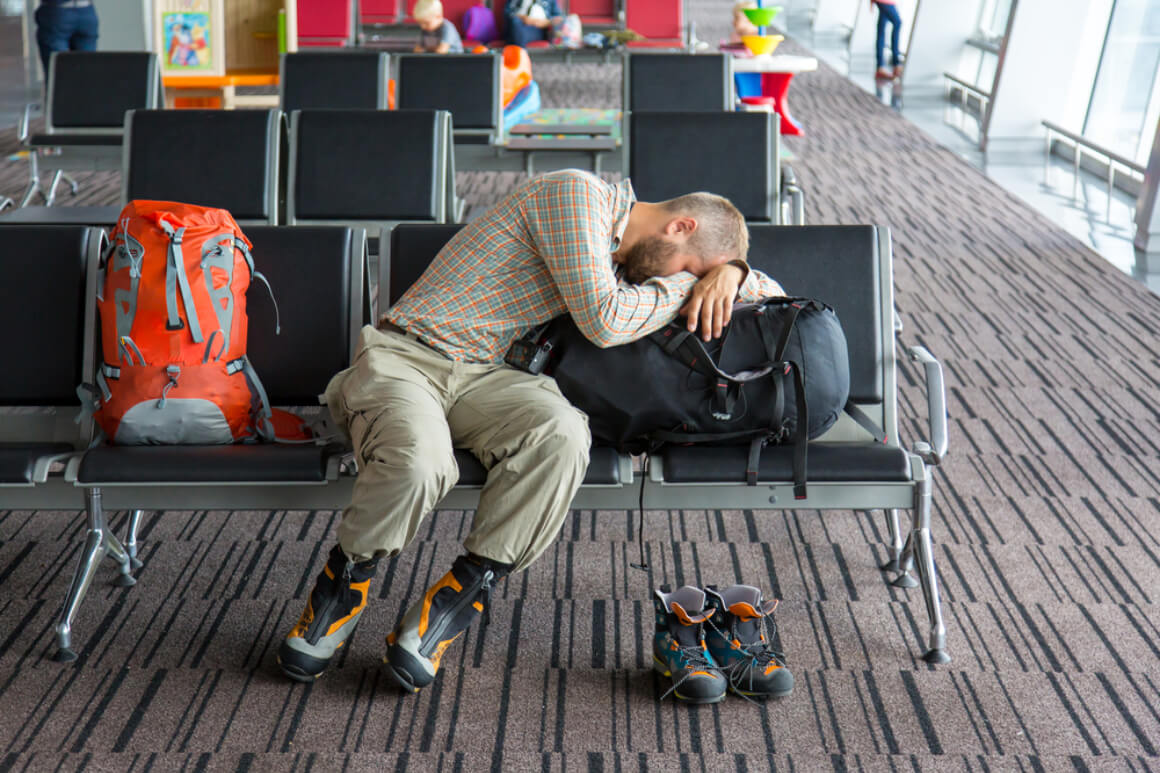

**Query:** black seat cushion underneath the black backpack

left=662, top=442, right=911, bottom=483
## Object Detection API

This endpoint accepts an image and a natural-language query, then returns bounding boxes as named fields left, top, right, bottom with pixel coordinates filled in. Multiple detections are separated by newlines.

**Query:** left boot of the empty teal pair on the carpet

left=653, top=585, right=728, bottom=703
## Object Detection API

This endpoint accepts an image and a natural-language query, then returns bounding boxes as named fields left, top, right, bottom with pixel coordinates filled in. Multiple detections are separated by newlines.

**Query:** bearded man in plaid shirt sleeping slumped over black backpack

left=278, top=169, right=783, bottom=692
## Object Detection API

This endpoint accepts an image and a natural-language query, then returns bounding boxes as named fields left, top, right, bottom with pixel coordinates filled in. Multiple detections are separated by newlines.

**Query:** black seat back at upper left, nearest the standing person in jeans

left=44, top=51, right=161, bottom=135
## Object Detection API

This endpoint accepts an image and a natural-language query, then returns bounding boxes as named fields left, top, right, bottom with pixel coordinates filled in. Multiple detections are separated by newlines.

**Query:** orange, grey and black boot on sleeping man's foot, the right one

left=383, top=556, right=512, bottom=693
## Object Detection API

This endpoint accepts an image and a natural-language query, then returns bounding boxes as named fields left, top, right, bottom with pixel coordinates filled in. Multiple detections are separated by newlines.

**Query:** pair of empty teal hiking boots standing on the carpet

left=653, top=585, right=793, bottom=703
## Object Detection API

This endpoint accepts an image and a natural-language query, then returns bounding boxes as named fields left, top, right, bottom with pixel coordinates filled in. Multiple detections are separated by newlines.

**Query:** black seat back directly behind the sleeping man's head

left=624, top=111, right=781, bottom=223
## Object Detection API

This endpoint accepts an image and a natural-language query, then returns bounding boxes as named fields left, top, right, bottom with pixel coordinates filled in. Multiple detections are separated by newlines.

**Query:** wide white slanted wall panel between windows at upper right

left=988, top=0, right=1111, bottom=140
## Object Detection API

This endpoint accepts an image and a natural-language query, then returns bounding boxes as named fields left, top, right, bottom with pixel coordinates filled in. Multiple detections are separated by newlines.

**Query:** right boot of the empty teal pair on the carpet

left=705, top=585, right=793, bottom=698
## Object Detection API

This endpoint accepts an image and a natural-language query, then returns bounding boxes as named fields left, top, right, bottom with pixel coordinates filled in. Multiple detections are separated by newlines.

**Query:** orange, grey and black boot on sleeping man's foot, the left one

left=278, top=546, right=378, bottom=681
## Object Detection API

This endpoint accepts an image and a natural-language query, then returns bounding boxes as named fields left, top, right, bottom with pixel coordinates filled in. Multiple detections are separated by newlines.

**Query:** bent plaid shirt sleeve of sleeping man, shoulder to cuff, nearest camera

left=524, top=174, right=697, bottom=347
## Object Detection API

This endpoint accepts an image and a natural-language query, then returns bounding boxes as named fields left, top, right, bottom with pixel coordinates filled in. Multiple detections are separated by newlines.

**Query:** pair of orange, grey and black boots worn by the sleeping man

left=278, top=546, right=510, bottom=693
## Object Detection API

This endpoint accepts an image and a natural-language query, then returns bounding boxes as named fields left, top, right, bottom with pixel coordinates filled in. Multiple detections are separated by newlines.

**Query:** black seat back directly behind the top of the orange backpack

left=122, top=110, right=285, bottom=225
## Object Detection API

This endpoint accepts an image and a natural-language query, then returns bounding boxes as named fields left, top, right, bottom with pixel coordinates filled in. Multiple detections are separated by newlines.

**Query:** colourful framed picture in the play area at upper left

left=153, top=0, right=225, bottom=77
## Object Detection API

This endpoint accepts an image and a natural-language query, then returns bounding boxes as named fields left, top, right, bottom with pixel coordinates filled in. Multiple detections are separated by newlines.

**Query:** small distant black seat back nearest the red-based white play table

left=622, top=53, right=733, bottom=113
